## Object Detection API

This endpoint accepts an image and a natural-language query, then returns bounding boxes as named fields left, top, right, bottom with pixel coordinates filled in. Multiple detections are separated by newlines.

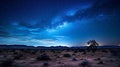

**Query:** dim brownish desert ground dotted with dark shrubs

left=0, top=49, right=120, bottom=67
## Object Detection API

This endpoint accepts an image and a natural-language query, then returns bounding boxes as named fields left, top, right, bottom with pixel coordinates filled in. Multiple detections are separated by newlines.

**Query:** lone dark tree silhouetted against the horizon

left=87, top=40, right=99, bottom=53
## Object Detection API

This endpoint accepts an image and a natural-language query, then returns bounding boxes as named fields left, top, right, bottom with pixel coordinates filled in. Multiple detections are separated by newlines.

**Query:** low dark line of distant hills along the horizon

left=0, top=45, right=120, bottom=49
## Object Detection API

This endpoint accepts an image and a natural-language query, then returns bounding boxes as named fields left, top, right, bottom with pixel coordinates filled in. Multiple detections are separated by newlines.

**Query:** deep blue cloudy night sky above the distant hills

left=0, top=0, right=120, bottom=46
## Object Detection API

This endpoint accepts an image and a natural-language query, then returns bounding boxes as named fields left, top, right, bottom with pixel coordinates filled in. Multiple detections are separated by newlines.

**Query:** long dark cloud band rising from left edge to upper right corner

left=0, top=0, right=120, bottom=36
